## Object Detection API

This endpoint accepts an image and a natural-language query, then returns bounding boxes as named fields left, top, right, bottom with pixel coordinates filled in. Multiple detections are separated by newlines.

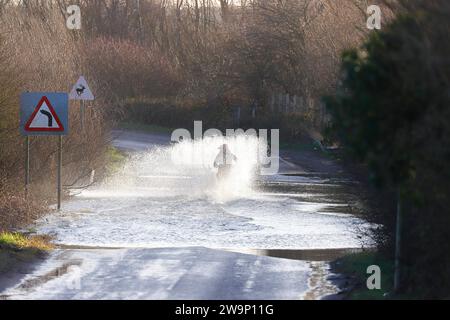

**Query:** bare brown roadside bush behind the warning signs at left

left=0, top=5, right=109, bottom=230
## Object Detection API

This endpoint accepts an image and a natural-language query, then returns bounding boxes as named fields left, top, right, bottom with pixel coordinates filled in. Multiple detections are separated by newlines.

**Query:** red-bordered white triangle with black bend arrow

left=25, top=96, right=64, bottom=131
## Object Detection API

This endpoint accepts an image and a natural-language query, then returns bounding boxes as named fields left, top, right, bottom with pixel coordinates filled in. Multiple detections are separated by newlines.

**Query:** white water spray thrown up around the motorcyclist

left=87, top=135, right=259, bottom=202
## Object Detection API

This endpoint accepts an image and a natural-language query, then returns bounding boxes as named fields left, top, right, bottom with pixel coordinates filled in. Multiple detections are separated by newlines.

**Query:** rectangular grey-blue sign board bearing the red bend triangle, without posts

left=20, top=92, right=68, bottom=136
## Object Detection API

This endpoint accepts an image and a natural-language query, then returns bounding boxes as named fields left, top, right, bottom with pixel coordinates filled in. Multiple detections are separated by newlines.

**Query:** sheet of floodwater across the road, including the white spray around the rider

left=35, top=132, right=368, bottom=250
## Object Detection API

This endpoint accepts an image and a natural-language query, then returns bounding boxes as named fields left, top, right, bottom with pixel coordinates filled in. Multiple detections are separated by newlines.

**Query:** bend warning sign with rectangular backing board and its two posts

left=20, top=92, right=69, bottom=210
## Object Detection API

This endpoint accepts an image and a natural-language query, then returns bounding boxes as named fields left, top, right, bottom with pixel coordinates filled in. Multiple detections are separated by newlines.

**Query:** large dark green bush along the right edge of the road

left=326, top=1, right=450, bottom=297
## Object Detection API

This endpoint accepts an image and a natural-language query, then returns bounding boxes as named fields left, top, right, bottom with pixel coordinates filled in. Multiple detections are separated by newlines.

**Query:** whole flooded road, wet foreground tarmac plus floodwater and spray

left=2, top=132, right=370, bottom=299
